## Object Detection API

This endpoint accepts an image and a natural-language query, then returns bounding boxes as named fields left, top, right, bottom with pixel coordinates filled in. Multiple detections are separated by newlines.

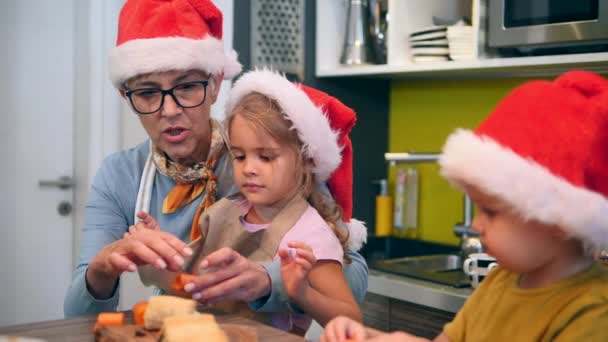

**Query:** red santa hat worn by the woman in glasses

left=109, top=0, right=241, bottom=87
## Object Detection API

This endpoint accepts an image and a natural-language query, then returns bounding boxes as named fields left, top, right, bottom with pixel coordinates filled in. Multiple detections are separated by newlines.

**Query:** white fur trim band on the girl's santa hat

left=226, top=70, right=342, bottom=182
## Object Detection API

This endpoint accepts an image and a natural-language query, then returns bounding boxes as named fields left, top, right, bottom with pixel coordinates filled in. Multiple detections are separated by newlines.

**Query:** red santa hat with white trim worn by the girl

left=226, top=70, right=367, bottom=250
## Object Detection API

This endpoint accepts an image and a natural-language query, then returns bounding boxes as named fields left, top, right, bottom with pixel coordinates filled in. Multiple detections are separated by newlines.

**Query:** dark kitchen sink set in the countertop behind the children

left=369, top=254, right=471, bottom=287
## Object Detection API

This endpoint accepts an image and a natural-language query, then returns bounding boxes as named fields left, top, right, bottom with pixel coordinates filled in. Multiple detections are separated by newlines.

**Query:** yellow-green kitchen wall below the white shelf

left=389, top=78, right=536, bottom=245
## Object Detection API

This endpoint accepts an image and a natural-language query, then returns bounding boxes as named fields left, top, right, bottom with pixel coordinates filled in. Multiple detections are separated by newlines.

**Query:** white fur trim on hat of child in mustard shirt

left=439, top=129, right=608, bottom=249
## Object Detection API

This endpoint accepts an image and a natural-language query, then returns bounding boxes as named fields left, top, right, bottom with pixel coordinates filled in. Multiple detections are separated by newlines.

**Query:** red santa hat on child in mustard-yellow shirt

left=439, top=71, right=608, bottom=249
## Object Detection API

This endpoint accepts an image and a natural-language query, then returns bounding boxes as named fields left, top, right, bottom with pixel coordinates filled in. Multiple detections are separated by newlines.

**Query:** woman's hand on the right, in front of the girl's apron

left=184, top=247, right=271, bottom=303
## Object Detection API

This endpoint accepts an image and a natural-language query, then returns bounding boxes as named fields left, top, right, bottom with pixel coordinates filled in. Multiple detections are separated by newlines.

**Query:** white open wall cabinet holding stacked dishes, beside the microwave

left=315, top=0, right=608, bottom=79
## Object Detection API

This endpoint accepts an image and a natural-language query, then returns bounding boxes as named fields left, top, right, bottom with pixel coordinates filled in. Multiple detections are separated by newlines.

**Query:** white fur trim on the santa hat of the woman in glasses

left=109, top=36, right=242, bottom=88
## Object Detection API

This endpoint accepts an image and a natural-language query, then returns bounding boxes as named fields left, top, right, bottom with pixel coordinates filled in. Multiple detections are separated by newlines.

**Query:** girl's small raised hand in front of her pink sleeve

left=279, top=242, right=317, bottom=298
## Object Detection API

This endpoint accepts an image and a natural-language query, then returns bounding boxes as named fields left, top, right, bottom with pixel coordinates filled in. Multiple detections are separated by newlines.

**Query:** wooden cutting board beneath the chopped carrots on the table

left=95, top=324, right=258, bottom=342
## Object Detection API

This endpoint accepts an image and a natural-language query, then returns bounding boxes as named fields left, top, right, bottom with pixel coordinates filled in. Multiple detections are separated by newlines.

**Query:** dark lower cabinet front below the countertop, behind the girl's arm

left=361, top=293, right=455, bottom=339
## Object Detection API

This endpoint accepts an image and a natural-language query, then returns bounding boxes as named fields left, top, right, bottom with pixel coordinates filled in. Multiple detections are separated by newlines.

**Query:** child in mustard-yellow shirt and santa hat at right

left=321, top=71, right=608, bottom=342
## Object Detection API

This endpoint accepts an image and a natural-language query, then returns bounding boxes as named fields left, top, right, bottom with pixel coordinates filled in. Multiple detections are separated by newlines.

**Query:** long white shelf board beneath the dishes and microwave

left=317, top=52, right=608, bottom=79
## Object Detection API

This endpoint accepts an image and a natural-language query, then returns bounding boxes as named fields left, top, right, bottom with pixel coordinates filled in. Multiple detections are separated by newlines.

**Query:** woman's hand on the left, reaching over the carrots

left=86, top=213, right=192, bottom=298
